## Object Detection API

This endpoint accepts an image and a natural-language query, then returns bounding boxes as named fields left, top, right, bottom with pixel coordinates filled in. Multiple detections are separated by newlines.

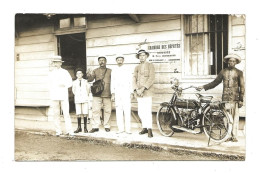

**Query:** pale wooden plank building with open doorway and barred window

left=14, top=14, right=246, bottom=128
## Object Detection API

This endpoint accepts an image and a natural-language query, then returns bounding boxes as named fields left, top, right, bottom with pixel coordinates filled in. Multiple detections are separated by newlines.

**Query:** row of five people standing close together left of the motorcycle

left=50, top=50, right=155, bottom=138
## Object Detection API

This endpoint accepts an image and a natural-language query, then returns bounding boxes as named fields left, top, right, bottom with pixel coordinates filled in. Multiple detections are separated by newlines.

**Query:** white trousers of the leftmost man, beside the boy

left=52, top=100, right=73, bottom=134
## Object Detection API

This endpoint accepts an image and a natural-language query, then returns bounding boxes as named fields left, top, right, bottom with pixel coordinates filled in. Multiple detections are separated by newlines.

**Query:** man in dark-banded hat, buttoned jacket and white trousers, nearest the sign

left=133, top=50, right=155, bottom=138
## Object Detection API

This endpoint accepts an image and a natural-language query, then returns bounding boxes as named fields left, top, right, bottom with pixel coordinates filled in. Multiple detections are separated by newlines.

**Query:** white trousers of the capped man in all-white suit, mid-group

left=115, top=93, right=131, bottom=132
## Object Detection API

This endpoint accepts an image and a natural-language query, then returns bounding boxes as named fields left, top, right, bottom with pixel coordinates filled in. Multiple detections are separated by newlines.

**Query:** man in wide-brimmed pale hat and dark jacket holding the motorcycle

left=197, top=54, right=245, bottom=142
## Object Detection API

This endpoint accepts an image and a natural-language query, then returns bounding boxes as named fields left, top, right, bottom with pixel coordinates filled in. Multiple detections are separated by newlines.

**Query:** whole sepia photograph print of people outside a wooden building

left=14, top=13, right=247, bottom=162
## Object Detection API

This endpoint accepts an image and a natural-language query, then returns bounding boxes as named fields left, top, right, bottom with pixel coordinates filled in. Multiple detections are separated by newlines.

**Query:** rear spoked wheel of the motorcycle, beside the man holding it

left=202, top=110, right=232, bottom=143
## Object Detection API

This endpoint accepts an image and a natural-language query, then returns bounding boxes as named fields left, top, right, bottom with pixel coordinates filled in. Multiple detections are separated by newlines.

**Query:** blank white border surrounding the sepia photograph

left=0, top=0, right=260, bottom=173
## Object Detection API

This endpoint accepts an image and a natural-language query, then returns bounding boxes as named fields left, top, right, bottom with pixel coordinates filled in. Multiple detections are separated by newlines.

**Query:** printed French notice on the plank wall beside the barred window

left=147, top=41, right=181, bottom=62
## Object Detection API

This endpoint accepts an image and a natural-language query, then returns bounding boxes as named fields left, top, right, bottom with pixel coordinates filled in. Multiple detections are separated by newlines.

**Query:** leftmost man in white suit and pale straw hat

left=49, top=56, right=74, bottom=136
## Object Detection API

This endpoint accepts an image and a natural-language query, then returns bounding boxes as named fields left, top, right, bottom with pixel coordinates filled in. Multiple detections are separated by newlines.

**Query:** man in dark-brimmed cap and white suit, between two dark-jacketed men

left=111, top=55, right=133, bottom=134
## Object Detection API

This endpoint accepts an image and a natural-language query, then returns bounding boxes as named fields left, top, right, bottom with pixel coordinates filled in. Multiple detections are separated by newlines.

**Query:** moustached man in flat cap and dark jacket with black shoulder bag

left=87, top=56, right=112, bottom=133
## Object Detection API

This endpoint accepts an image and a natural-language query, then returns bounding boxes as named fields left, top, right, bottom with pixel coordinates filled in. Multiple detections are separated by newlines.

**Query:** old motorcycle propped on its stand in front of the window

left=156, top=78, right=232, bottom=145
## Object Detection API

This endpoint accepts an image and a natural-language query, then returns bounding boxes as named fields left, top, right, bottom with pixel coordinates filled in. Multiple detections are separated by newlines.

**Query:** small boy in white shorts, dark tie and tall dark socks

left=72, top=68, right=91, bottom=133
